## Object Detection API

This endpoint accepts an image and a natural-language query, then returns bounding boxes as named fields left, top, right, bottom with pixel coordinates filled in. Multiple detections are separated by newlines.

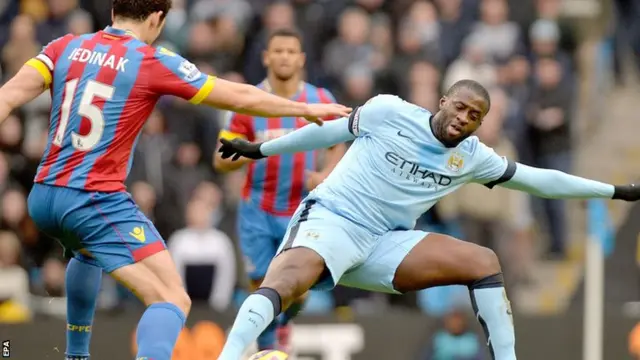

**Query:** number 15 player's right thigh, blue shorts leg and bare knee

left=73, top=193, right=191, bottom=313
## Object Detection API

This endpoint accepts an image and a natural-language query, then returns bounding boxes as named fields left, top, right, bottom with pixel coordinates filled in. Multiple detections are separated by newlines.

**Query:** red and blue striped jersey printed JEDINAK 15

left=27, top=27, right=215, bottom=192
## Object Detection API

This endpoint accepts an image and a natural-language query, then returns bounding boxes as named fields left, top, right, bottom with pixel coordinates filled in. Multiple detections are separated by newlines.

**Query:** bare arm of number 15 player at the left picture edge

left=0, top=65, right=51, bottom=123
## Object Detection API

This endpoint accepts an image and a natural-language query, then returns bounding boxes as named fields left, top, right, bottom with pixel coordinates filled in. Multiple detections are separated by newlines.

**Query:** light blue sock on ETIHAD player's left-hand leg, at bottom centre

left=218, top=288, right=282, bottom=360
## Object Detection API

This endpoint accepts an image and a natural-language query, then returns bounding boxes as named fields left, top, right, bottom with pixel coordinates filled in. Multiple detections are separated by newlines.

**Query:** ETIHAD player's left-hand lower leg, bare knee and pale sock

left=218, top=247, right=325, bottom=360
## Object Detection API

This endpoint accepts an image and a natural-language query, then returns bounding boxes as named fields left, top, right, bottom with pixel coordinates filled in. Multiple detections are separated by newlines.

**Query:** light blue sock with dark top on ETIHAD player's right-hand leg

left=469, top=273, right=516, bottom=360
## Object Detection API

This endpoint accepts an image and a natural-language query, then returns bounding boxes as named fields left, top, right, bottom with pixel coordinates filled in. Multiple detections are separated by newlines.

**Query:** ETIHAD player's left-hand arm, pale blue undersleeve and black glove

left=218, top=118, right=355, bottom=161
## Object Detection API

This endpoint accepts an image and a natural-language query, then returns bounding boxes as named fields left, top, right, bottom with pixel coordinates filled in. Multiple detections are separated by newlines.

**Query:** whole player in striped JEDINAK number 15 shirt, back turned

left=0, top=0, right=350, bottom=360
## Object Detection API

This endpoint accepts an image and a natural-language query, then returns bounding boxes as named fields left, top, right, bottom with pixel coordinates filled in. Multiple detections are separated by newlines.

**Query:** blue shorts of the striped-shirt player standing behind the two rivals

left=237, top=202, right=282, bottom=282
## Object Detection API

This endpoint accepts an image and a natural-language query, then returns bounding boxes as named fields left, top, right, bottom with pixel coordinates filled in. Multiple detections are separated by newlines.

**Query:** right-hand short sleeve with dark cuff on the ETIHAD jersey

left=473, top=142, right=516, bottom=189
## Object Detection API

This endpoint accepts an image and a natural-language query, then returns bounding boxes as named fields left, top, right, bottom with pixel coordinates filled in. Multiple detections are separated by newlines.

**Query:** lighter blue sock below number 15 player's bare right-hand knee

left=136, top=303, right=186, bottom=360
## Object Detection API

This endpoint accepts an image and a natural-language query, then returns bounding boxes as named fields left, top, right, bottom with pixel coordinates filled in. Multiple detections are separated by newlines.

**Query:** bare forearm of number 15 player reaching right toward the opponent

left=203, top=78, right=352, bottom=125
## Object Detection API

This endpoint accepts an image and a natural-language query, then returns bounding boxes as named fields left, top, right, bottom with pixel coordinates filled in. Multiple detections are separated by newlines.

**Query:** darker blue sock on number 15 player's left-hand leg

left=65, top=259, right=102, bottom=360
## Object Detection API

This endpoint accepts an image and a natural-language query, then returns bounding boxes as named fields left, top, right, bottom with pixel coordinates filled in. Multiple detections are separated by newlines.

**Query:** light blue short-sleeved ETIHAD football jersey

left=307, top=95, right=515, bottom=234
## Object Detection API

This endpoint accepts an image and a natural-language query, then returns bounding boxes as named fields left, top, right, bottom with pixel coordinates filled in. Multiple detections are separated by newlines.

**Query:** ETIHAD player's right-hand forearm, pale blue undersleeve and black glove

left=501, top=163, right=640, bottom=201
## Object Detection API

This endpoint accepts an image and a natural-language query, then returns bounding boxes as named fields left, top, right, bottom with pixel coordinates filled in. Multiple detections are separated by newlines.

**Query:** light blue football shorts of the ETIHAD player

left=277, top=200, right=428, bottom=294
